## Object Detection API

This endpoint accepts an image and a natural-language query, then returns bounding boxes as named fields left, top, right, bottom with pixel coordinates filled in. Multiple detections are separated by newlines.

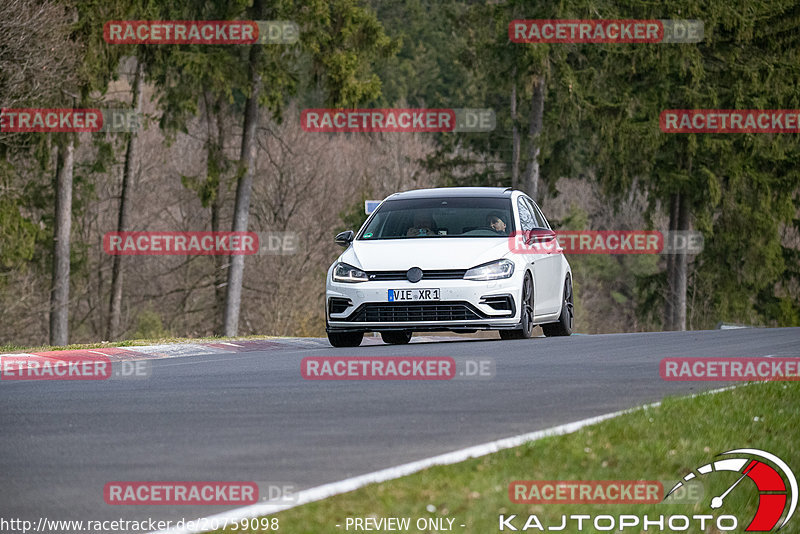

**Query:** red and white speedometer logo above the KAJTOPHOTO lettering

left=665, top=449, right=797, bottom=532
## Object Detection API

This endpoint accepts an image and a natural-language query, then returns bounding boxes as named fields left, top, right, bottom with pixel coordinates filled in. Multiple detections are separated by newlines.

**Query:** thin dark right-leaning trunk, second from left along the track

left=106, top=62, right=144, bottom=341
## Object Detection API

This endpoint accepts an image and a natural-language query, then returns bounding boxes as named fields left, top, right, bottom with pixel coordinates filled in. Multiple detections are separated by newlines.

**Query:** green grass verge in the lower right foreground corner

left=219, top=382, right=800, bottom=534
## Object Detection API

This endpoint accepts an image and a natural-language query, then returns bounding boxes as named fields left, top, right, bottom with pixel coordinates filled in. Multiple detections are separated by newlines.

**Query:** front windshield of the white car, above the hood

left=359, top=197, right=514, bottom=241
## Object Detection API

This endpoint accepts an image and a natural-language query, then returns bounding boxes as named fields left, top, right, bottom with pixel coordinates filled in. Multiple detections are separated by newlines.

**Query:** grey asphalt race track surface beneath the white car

left=0, top=328, right=800, bottom=521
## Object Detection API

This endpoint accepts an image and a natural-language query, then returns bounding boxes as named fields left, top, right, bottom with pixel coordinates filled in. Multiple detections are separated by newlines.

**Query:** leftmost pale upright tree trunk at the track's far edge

left=50, top=134, right=75, bottom=346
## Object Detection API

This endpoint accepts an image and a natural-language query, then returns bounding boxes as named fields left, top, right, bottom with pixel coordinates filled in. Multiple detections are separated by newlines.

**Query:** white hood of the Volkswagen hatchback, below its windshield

left=339, top=237, right=509, bottom=271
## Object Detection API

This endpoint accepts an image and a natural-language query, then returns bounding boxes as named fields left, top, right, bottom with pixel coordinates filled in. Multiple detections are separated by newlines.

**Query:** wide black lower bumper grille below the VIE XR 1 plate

left=346, top=302, right=486, bottom=323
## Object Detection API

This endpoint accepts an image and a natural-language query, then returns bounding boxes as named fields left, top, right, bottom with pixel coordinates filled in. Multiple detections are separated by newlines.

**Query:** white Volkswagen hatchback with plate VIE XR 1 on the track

left=325, top=187, right=574, bottom=347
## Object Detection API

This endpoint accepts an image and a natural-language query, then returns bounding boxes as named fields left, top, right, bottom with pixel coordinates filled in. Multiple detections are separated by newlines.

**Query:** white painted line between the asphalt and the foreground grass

left=149, top=385, right=742, bottom=534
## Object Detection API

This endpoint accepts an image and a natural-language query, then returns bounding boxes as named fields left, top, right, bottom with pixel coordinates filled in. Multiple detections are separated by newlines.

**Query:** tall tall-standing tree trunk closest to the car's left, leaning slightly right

left=225, top=22, right=261, bottom=336
